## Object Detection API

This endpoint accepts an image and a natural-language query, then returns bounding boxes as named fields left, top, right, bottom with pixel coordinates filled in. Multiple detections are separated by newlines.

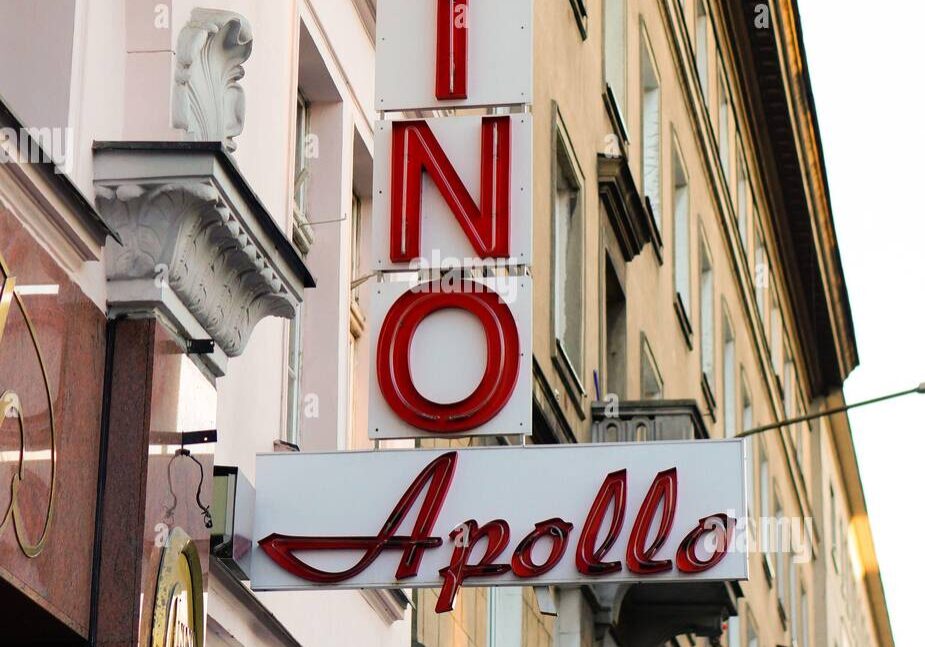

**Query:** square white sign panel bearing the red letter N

left=372, top=114, right=533, bottom=270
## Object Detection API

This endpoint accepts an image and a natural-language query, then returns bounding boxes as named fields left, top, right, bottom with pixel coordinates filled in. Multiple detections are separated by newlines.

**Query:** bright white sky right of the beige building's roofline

left=799, top=0, right=925, bottom=647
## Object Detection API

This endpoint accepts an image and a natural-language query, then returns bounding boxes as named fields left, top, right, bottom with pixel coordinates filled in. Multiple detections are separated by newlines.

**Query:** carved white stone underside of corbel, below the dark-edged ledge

left=97, top=182, right=295, bottom=357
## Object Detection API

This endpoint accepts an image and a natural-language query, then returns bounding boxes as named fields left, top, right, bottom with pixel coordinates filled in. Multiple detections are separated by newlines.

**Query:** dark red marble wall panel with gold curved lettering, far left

left=0, top=207, right=106, bottom=636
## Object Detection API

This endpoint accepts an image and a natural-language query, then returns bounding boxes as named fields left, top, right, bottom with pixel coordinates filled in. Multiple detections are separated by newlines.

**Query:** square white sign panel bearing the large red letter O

left=369, top=271, right=533, bottom=440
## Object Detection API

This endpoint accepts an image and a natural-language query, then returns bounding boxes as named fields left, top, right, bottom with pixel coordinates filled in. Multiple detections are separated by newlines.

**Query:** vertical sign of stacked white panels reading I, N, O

left=369, top=0, right=533, bottom=439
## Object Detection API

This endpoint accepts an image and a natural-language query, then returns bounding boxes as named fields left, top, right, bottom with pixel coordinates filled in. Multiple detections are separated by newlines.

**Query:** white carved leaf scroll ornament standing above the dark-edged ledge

left=172, top=9, right=254, bottom=151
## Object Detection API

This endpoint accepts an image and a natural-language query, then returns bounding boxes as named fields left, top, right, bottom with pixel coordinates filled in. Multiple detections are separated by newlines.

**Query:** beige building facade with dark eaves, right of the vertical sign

left=415, top=0, right=892, bottom=647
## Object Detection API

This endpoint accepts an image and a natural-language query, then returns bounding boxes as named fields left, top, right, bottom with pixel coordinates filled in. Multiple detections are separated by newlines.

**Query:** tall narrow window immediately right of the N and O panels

left=553, top=131, right=584, bottom=382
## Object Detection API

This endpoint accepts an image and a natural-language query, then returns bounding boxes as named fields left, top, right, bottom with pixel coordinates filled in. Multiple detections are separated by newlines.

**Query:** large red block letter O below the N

left=376, top=279, right=520, bottom=434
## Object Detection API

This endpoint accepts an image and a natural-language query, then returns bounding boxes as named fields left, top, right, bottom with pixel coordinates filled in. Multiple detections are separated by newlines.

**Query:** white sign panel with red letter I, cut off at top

left=376, top=0, right=533, bottom=111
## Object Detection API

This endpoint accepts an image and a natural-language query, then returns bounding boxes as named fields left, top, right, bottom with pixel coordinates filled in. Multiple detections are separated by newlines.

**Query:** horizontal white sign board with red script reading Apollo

left=251, top=440, right=748, bottom=611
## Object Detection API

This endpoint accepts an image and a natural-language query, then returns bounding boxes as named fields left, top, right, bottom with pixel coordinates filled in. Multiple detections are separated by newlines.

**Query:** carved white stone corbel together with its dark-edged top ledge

left=94, top=142, right=314, bottom=375
